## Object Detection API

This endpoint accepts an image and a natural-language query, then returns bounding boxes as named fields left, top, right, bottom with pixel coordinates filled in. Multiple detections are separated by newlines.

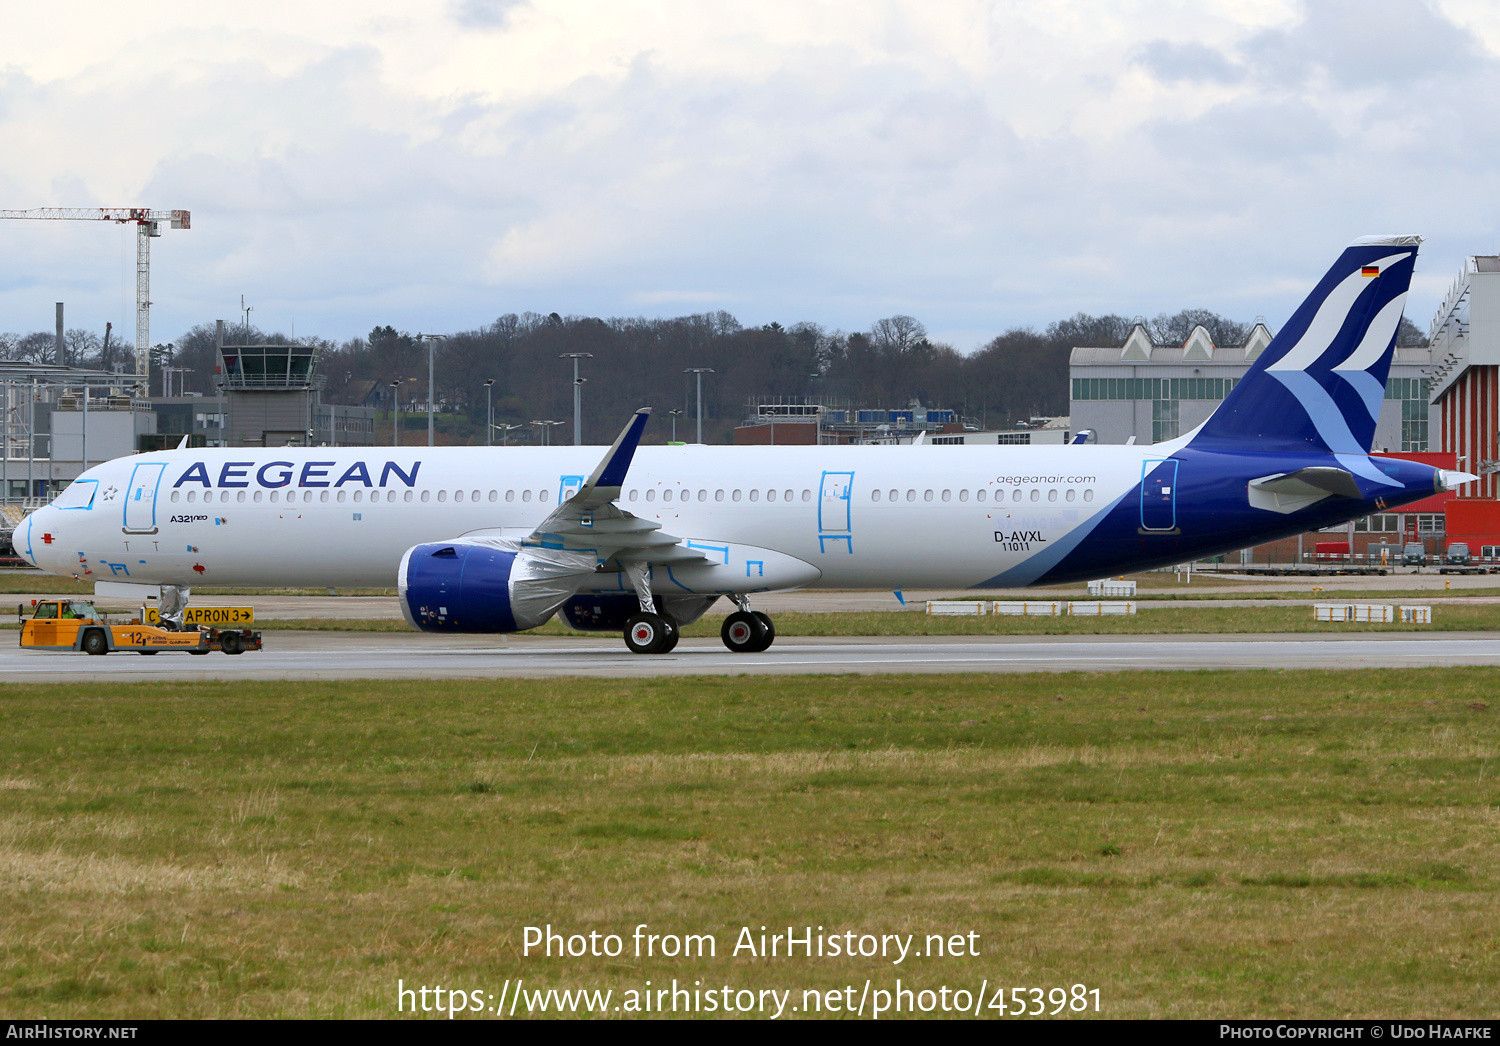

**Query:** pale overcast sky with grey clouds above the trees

left=0, top=0, right=1500, bottom=351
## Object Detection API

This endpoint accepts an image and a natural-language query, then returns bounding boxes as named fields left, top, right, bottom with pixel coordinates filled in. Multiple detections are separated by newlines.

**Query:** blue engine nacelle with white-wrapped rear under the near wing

left=396, top=537, right=594, bottom=632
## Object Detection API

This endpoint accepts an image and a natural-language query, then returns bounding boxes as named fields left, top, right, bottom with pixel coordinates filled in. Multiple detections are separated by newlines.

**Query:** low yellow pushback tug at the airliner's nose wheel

left=15, top=599, right=261, bottom=654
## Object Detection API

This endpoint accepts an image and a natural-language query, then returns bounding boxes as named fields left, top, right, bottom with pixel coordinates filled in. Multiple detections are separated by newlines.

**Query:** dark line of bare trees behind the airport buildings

left=0, top=309, right=1425, bottom=443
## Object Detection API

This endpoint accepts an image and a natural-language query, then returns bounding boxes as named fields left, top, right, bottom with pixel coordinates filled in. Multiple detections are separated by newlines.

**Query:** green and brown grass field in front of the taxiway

left=0, top=669, right=1500, bottom=1017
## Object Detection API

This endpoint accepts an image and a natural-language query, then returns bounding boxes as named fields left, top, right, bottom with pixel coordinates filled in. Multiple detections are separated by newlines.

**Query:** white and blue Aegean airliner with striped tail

left=15, top=236, right=1473, bottom=653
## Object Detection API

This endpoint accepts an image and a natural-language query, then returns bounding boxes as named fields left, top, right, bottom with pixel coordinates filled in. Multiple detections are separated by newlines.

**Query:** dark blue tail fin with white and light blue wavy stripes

left=1193, top=236, right=1422, bottom=455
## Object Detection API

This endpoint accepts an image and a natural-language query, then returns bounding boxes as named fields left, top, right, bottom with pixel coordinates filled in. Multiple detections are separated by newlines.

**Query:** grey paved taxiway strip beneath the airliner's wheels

left=11, top=630, right=1500, bottom=683
